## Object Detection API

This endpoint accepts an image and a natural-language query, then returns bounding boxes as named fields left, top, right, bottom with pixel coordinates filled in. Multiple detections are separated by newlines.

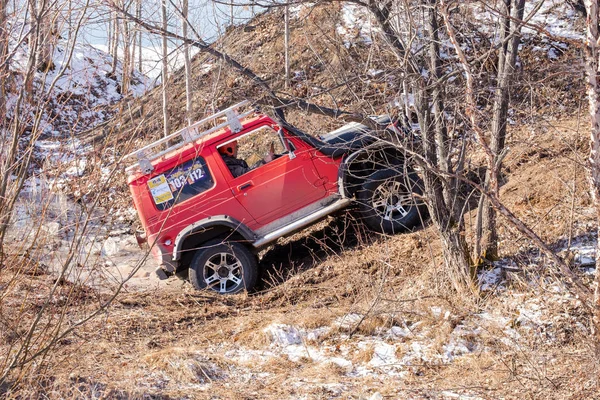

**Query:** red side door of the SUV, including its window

left=221, top=125, right=327, bottom=225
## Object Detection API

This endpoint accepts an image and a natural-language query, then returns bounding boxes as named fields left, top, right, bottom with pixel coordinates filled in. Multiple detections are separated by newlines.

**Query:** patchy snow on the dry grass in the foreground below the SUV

left=136, top=274, right=586, bottom=398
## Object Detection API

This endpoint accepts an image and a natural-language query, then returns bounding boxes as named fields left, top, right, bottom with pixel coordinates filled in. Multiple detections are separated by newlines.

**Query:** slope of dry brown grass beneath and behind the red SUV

left=0, top=3, right=598, bottom=399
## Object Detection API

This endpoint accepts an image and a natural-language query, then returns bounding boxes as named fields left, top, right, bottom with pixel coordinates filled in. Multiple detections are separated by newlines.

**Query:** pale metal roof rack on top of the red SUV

left=123, top=100, right=254, bottom=174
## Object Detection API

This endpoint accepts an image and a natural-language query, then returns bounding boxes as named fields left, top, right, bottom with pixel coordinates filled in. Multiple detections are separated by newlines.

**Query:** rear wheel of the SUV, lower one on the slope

left=189, top=242, right=257, bottom=294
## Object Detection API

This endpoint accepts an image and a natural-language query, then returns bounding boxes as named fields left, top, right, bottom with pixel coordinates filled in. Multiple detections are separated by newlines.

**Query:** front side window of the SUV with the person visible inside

left=218, top=126, right=287, bottom=177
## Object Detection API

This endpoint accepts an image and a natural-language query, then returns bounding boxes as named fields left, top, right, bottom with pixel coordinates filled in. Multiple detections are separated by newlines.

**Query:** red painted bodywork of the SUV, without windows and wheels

left=129, top=116, right=341, bottom=263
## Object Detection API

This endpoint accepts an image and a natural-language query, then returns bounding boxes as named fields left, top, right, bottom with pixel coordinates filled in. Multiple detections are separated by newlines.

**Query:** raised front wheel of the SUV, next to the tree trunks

left=357, top=169, right=426, bottom=234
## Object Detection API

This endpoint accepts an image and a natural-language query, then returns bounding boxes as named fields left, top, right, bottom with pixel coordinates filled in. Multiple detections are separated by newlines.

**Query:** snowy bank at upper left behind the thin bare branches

left=7, top=23, right=153, bottom=141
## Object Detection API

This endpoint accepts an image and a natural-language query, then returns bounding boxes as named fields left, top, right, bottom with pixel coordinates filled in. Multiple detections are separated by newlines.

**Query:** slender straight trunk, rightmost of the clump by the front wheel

left=476, top=0, right=525, bottom=260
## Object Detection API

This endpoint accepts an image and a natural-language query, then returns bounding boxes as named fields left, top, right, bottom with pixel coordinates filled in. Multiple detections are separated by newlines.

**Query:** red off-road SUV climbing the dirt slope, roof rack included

left=127, top=102, right=422, bottom=293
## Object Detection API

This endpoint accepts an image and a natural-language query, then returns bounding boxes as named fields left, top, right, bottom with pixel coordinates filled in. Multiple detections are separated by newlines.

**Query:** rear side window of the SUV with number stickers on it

left=148, top=157, right=214, bottom=211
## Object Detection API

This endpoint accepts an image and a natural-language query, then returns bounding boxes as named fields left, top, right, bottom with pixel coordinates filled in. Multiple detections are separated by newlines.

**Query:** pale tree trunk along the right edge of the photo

left=585, top=0, right=600, bottom=353
